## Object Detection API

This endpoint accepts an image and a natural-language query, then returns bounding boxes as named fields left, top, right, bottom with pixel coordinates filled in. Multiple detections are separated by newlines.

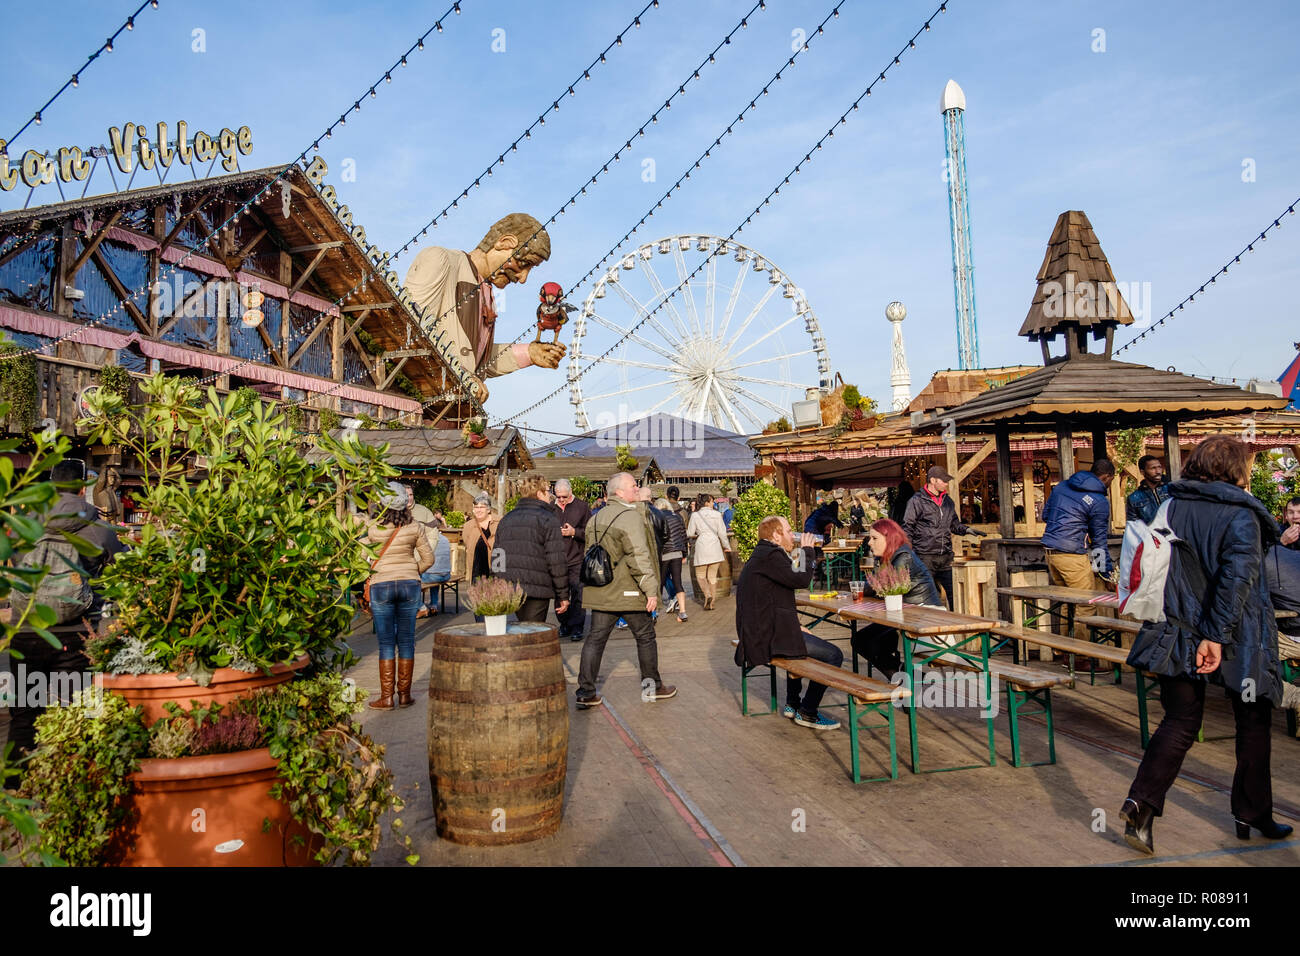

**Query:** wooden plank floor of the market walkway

left=352, top=598, right=1300, bottom=866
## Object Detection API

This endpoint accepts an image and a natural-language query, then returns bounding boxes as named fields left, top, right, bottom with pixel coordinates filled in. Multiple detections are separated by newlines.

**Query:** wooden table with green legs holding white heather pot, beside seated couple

left=837, top=601, right=1002, bottom=774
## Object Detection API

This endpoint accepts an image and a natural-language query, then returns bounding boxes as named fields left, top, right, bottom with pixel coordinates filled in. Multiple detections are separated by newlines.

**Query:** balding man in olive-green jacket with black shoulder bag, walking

left=577, top=471, right=677, bottom=710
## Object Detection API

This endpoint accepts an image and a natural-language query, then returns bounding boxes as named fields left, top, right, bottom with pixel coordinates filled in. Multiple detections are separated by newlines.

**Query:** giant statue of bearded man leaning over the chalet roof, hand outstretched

left=406, top=212, right=566, bottom=400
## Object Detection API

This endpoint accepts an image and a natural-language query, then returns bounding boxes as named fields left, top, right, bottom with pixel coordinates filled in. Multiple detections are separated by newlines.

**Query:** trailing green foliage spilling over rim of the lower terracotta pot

left=22, top=674, right=412, bottom=866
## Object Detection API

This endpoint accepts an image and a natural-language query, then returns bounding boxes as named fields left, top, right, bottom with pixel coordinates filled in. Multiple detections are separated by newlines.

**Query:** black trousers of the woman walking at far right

left=1128, top=678, right=1273, bottom=823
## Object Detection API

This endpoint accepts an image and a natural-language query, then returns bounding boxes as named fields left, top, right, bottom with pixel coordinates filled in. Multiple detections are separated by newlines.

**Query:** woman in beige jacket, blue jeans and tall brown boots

left=365, top=481, right=433, bottom=710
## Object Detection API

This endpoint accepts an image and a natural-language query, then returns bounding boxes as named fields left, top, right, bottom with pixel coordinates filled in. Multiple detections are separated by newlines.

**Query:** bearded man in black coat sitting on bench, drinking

left=736, top=515, right=844, bottom=730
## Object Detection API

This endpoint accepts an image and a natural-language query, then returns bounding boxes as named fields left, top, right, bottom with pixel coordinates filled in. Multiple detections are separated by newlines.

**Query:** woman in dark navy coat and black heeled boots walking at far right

left=1121, top=436, right=1291, bottom=853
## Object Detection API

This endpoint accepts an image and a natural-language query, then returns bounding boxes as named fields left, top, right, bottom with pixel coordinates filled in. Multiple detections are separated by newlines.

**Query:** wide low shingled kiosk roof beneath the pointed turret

left=917, top=356, right=1287, bottom=432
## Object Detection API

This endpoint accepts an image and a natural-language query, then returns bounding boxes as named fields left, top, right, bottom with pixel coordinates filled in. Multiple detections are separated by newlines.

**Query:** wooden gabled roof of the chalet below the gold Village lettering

left=0, top=165, right=470, bottom=416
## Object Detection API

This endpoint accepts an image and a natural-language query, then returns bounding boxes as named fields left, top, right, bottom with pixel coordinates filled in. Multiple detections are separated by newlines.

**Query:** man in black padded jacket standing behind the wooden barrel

left=491, top=476, right=569, bottom=623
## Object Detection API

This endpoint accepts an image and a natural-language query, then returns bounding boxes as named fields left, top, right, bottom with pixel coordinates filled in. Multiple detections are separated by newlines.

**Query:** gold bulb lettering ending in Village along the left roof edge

left=0, top=120, right=252, bottom=193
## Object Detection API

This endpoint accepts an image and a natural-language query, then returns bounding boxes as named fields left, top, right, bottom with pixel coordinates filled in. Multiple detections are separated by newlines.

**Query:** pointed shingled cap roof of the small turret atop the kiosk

left=1019, top=209, right=1134, bottom=341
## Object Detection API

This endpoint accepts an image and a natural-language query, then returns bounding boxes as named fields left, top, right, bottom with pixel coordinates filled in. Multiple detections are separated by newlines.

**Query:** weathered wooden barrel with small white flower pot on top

left=429, top=623, right=568, bottom=847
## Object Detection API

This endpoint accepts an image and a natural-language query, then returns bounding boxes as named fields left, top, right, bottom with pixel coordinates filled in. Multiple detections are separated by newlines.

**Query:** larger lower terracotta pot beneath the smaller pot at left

left=122, top=747, right=321, bottom=866
